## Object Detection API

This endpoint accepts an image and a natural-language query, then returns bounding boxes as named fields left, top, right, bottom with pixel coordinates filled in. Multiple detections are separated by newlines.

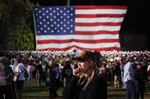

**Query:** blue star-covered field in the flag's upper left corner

left=35, top=7, right=75, bottom=35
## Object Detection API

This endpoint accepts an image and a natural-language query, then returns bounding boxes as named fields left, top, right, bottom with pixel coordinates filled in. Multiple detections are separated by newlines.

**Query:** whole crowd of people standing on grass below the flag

left=0, top=51, right=150, bottom=99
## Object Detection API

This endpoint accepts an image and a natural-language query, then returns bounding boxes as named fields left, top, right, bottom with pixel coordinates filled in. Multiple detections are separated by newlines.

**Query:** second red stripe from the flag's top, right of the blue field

left=75, top=14, right=125, bottom=18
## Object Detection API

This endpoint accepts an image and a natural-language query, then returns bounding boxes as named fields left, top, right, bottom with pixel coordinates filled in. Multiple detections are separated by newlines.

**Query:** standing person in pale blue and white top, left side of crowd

left=15, top=55, right=25, bottom=99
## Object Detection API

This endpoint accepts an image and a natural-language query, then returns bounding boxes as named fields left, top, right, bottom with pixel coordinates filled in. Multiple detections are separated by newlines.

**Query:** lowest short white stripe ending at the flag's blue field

left=75, top=26, right=120, bottom=32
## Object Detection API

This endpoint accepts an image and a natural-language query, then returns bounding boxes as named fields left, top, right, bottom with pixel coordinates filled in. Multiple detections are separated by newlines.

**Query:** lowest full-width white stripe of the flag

left=37, top=42, right=120, bottom=49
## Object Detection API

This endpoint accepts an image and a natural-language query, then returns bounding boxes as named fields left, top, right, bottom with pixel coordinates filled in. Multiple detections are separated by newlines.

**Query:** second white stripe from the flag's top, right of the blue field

left=75, top=17, right=124, bottom=23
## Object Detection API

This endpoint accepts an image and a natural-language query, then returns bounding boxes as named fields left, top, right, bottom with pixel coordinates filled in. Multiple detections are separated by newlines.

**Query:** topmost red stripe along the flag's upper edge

left=75, top=5, right=127, bottom=9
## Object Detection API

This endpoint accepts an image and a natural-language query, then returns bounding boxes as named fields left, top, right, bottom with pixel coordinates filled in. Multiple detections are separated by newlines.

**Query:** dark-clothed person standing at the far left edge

left=0, top=56, right=14, bottom=99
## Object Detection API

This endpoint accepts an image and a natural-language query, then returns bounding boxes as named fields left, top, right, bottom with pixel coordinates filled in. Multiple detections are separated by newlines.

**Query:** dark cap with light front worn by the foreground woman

left=76, top=50, right=94, bottom=62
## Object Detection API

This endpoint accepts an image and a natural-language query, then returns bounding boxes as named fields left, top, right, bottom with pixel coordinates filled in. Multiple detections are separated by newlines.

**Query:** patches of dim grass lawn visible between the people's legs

left=23, top=80, right=150, bottom=99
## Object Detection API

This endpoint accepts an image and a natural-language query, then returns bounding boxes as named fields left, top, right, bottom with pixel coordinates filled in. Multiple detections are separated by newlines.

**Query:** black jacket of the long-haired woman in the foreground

left=64, top=75, right=107, bottom=99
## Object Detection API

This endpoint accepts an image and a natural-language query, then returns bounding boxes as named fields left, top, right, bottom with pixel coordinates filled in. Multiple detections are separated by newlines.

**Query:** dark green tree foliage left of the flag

left=0, top=0, right=35, bottom=50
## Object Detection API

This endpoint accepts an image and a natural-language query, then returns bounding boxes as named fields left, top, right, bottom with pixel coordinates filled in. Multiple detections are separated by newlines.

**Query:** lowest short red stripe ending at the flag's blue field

left=76, top=31, right=119, bottom=35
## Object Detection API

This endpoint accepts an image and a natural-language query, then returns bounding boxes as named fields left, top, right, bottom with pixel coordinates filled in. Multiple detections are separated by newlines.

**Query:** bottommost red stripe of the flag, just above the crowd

left=37, top=46, right=121, bottom=52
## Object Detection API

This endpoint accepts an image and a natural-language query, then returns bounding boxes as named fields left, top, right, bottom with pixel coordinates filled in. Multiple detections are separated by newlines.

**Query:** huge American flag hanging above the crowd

left=33, top=5, right=127, bottom=51
